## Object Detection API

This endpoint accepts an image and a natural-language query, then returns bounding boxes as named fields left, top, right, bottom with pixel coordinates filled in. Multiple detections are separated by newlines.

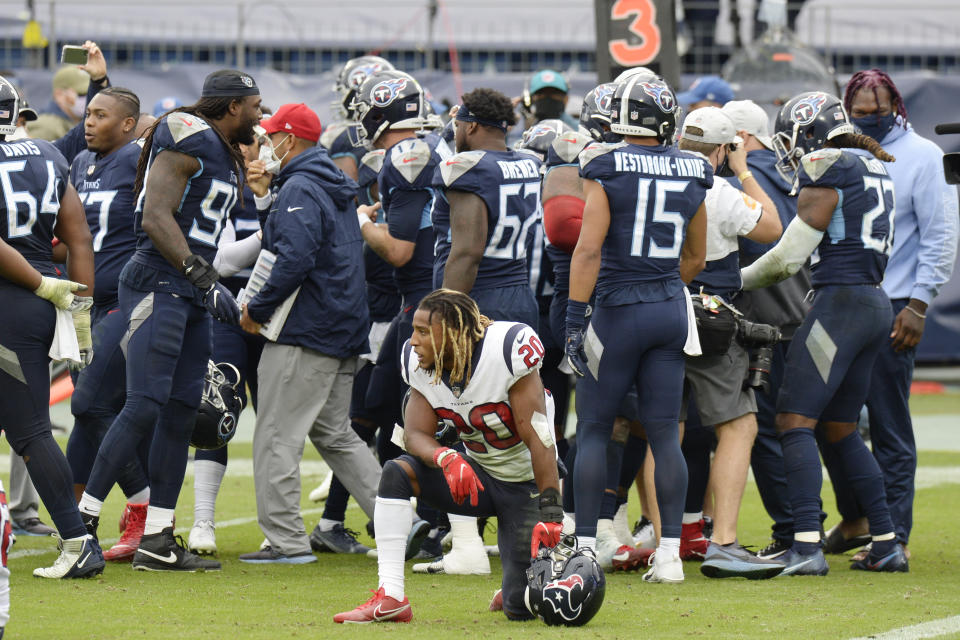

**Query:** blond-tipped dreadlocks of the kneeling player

left=419, top=288, right=493, bottom=386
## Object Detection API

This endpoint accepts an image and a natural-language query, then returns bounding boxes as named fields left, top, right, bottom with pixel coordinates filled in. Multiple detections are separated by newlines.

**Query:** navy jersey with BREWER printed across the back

left=434, top=149, right=541, bottom=290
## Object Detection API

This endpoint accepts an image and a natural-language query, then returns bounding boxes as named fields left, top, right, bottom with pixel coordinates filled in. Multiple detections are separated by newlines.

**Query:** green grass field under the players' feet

left=7, top=395, right=960, bottom=640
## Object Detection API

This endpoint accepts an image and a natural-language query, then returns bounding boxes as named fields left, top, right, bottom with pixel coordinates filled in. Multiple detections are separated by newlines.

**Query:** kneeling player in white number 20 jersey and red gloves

left=333, top=289, right=563, bottom=623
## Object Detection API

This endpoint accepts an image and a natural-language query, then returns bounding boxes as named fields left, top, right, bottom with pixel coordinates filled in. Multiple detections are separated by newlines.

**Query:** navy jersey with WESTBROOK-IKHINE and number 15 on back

left=580, top=142, right=713, bottom=306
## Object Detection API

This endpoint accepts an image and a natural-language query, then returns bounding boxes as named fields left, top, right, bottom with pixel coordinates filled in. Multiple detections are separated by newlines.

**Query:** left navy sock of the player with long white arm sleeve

left=780, top=428, right=823, bottom=553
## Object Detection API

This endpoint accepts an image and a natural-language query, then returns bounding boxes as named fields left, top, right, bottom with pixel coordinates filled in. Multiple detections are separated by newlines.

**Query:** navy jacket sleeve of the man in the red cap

left=247, top=183, right=324, bottom=324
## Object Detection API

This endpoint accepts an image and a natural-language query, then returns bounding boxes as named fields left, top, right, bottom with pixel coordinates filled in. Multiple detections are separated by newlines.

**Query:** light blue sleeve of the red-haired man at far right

left=894, top=153, right=960, bottom=304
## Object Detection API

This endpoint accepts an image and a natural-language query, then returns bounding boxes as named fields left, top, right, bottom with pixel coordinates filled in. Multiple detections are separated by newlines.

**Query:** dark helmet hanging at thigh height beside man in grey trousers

left=190, top=360, right=243, bottom=449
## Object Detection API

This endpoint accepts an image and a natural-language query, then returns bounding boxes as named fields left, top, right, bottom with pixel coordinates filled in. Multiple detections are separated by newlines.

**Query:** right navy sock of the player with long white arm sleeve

left=829, top=431, right=896, bottom=544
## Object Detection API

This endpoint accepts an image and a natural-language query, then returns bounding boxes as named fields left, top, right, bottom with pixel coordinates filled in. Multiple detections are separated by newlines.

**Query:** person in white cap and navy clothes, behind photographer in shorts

left=723, top=100, right=811, bottom=558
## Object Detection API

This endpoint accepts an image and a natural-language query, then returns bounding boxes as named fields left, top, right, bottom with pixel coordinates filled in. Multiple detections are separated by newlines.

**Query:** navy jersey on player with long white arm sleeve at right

left=797, top=149, right=894, bottom=288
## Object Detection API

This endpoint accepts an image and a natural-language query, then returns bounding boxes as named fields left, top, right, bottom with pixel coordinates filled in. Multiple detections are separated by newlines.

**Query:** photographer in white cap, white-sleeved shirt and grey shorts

left=679, top=107, right=783, bottom=578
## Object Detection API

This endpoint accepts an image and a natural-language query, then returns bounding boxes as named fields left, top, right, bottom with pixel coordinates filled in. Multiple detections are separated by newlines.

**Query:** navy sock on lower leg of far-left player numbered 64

left=20, top=431, right=87, bottom=539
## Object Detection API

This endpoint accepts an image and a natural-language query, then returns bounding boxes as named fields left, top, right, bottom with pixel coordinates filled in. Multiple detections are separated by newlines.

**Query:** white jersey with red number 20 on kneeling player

left=400, top=322, right=553, bottom=482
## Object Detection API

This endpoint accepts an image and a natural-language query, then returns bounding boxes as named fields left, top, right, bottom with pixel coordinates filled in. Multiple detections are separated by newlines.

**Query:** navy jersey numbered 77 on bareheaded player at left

left=70, top=142, right=142, bottom=308
